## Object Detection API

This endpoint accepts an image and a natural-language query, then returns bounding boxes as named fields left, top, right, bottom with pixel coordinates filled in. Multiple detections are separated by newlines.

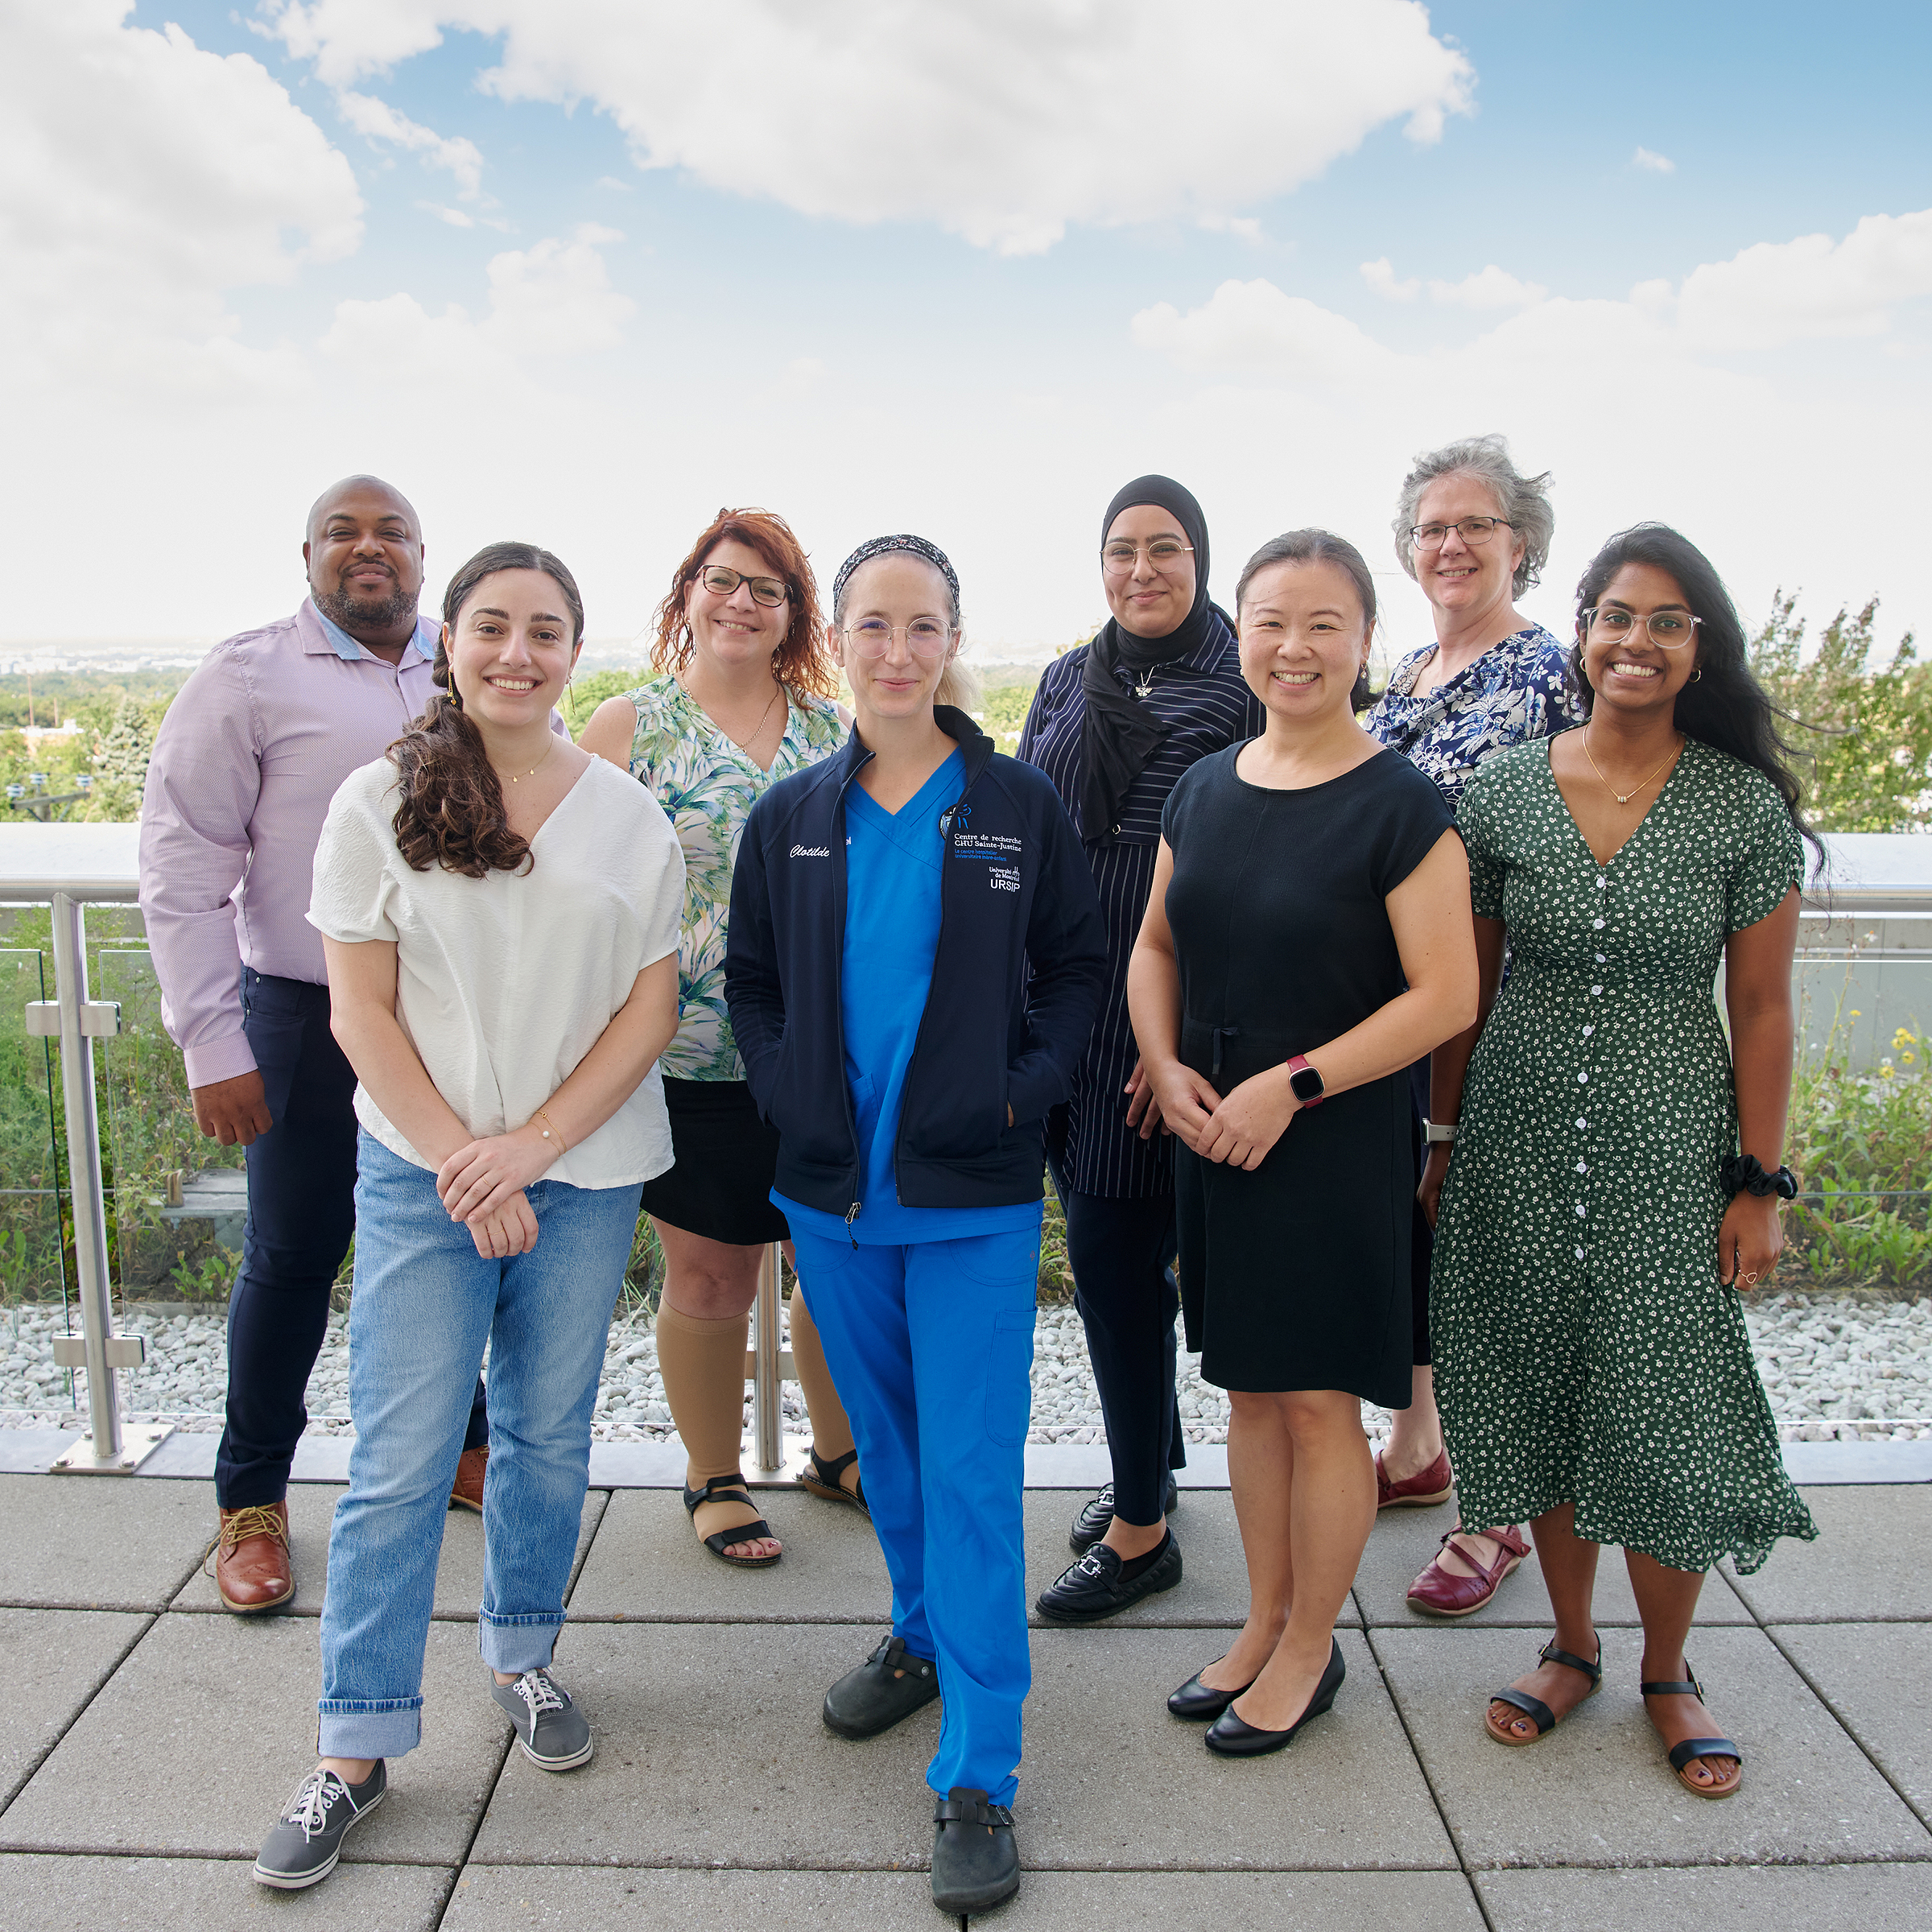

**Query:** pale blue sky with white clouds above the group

left=0, top=0, right=1932, bottom=664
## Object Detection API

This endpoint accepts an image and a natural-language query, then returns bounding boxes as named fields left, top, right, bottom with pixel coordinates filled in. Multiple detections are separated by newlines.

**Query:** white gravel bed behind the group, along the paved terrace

left=0, top=1290, right=1932, bottom=1443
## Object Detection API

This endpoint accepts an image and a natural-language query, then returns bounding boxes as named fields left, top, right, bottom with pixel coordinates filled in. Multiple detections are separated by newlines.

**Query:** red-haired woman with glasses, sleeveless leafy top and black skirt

left=581, top=510, right=864, bottom=1569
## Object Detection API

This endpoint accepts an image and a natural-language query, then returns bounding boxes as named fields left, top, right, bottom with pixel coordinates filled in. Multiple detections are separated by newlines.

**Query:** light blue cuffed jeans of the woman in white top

left=319, top=1134, right=643, bottom=1758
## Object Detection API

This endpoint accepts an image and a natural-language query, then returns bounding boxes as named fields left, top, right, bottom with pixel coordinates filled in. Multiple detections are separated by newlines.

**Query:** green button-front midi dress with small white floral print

left=1430, top=738, right=1818, bottom=1571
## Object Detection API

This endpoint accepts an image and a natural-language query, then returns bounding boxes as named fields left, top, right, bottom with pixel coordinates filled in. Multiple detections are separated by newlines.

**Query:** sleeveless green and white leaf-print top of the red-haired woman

left=624, top=672, right=844, bottom=1080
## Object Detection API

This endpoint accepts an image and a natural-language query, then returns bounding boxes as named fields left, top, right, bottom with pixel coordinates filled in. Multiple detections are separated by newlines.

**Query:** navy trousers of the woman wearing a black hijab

left=1053, top=1167, right=1188, bottom=1528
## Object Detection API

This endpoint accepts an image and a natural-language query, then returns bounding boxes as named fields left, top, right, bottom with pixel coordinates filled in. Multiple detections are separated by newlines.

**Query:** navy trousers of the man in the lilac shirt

left=214, top=968, right=489, bottom=1509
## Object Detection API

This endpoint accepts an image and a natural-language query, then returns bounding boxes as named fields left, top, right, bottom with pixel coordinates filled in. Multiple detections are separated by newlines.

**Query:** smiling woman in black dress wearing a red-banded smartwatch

left=1129, top=530, right=1476, bottom=1757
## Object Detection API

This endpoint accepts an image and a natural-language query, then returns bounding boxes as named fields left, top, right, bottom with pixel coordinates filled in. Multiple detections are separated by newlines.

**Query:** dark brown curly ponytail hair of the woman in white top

left=388, top=543, right=584, bottom=879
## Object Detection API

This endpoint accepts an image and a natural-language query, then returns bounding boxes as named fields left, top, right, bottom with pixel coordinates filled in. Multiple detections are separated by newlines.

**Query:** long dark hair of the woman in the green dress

left=1569, top=523, right=1826, bottom=873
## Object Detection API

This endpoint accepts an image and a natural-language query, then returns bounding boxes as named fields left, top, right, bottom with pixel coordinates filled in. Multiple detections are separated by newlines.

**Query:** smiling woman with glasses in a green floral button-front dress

left=1422, top=523, right=1816, bottom=1798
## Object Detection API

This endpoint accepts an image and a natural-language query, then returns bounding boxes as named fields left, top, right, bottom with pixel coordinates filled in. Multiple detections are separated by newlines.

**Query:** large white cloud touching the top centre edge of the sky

left=249, top=0, right=1474, bottom=255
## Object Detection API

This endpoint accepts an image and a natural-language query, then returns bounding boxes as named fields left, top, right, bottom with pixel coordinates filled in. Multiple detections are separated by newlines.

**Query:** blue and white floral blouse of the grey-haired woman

left=1362, top=624, right=1583, bottom=806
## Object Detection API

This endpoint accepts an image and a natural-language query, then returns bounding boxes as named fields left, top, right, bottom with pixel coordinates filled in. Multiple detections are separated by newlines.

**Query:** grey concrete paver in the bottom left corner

left=0, top=1847, right=454, bottom=1932
